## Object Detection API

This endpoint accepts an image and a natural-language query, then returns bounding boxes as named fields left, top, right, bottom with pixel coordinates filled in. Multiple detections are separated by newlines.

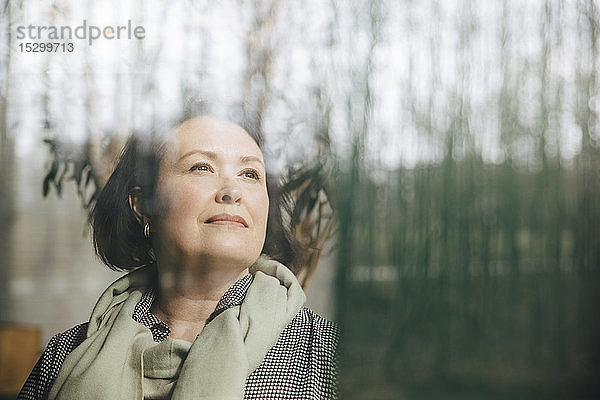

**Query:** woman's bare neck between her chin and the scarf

left=152, top=260, right=253, bottom=342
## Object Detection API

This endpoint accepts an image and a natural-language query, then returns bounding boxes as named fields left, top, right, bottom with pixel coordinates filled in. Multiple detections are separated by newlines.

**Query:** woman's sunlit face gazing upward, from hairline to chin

left=152, top=117, right=269, bottom=267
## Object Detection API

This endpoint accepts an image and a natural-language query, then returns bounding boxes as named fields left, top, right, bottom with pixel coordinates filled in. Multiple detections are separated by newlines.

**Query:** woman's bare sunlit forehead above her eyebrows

left=168, top=116, right=263, bottom=160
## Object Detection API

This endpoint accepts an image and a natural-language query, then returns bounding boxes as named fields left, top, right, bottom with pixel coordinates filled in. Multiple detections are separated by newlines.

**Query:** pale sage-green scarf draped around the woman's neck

left=49, top=256, right=306, bottom=400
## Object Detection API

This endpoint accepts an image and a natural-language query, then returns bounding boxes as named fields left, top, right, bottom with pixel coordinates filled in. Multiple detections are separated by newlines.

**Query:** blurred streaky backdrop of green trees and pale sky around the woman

left=0, top=0, right=600, bottom=399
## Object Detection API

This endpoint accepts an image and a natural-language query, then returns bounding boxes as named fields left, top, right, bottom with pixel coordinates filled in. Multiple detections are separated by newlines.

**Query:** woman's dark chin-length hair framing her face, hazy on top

left=90, top=101, right=301, bottom=273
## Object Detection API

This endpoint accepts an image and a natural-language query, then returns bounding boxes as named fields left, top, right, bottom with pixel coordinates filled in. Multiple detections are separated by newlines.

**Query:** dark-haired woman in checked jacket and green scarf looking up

left=18, top=104, right=336, bottom=399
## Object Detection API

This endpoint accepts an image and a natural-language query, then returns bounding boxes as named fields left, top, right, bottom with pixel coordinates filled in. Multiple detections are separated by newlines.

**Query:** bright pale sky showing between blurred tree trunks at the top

left=2, top=0, right=581, bottom=168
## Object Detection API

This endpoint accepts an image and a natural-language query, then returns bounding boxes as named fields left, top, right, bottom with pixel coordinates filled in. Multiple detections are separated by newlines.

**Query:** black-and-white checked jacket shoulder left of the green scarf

left=17, top=322, right=88, bottom=400
